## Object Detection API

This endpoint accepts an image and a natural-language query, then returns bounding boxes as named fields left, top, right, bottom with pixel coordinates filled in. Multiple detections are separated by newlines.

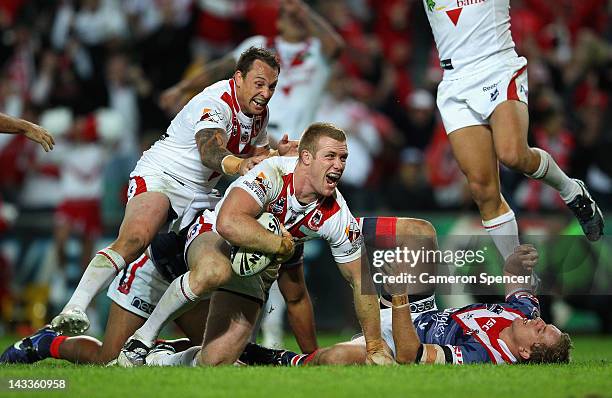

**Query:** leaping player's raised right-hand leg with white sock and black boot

left=490, top=100, right=603, bottom=240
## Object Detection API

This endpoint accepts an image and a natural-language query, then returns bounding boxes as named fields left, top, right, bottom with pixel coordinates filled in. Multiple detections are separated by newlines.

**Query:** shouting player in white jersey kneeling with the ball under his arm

left=118, top=123, right=390, bottom=366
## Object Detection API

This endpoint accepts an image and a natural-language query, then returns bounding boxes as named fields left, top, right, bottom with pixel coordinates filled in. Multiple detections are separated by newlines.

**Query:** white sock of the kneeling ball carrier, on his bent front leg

left=133, top=271, right=200, bottom=347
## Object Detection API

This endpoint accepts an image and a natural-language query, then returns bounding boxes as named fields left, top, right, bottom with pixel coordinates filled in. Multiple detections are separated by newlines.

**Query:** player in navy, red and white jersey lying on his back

left=237, top=245, right=571, bottom=366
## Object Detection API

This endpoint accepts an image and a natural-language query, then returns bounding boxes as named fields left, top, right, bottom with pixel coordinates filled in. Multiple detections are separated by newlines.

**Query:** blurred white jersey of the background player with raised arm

left=233, top=36, right=331, bottom=140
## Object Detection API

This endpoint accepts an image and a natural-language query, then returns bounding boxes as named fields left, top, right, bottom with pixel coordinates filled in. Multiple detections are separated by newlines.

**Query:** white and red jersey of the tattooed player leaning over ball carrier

left=137, top=79, right=268, bottom=193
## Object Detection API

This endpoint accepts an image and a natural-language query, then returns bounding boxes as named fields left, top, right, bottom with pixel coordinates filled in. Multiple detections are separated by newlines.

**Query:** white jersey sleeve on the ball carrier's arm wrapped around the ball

left=228, top=158, right=282, bottom=208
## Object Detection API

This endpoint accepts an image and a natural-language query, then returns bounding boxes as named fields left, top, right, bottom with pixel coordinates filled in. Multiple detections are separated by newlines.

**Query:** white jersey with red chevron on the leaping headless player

left=423, top=0, right=517, bottom=79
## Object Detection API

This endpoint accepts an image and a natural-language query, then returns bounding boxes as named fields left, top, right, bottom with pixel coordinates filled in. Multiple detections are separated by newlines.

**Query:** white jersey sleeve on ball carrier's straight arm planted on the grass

left=321, top=203, right=363, bottom=264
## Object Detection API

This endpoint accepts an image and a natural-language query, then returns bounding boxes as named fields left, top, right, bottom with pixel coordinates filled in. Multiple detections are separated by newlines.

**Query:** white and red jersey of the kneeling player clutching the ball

left=215, top=156, right=362, bottom=264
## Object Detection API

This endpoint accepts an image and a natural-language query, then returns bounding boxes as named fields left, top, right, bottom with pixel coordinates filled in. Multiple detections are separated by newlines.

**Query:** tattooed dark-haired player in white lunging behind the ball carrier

left=51, top=48, right=292, bottom=333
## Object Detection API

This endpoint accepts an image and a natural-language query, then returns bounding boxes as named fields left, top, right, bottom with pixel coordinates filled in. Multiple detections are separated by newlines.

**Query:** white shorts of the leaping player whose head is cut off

left=437, top=57, right=529, bottom=134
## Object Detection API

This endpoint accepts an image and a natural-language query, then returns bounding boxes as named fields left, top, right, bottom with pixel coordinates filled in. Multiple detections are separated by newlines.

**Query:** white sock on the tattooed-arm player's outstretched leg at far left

left=64, top=247, right=125, bottom=310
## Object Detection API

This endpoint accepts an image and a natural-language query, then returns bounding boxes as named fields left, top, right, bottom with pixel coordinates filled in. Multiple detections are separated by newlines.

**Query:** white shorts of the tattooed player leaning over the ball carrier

left=127, top=164, right=221, bottom=233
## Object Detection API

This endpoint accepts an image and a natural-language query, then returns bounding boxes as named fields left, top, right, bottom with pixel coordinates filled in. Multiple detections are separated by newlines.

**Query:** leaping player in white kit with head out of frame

left=423, top=0, right=604, bottom=258
